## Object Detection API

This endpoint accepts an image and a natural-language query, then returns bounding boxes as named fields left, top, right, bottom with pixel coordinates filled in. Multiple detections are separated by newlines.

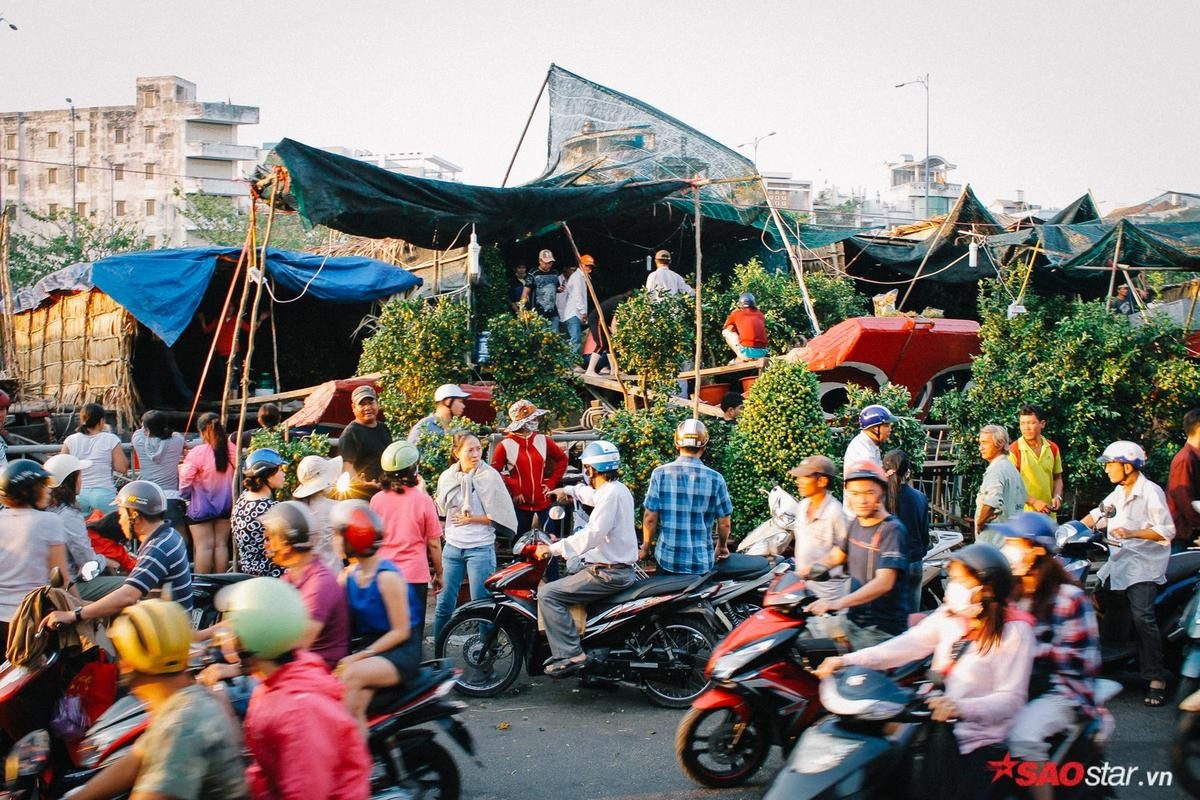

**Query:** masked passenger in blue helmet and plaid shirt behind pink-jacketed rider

left=995, top=511, right=1100, bottom=800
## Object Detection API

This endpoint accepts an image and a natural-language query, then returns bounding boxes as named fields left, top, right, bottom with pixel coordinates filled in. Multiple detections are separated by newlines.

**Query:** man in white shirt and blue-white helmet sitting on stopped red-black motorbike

left=538, top=441, right=637, bottom=678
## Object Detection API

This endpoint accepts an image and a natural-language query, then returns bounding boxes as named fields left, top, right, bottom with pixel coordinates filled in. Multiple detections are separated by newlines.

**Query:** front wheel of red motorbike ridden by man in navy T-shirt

left=676, top=708, right=770, bottom=789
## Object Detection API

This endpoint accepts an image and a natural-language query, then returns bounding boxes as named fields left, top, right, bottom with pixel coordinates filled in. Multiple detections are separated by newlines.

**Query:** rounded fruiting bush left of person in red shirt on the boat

left=612, top=289, right=696, bottom=402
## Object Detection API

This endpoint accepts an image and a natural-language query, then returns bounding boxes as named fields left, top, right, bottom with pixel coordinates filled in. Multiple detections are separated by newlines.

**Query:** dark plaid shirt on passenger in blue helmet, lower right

left=1021, top=584, right=1100, bottom=716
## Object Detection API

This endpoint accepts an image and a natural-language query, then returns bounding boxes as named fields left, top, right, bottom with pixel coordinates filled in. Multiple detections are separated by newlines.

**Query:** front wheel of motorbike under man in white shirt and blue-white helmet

left=433, top=614, right=521, bottom=697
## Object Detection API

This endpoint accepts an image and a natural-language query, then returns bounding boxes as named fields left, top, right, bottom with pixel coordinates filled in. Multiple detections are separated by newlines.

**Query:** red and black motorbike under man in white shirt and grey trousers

left=434, top=529, right=721, bottom=708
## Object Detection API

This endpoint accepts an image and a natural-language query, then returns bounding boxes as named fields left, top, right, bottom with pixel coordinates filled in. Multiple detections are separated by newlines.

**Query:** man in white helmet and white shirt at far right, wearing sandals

left=1082, top=441, right=1175, bottom=705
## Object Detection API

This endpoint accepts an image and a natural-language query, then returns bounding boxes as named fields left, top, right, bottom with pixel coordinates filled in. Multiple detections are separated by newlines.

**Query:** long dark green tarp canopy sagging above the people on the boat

left=275, top=139, right=690, bottom=249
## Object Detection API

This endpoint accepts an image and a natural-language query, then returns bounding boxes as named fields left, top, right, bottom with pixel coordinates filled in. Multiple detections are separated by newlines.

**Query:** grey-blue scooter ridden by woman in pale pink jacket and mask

left=763, top=667, right=1121, bottom=800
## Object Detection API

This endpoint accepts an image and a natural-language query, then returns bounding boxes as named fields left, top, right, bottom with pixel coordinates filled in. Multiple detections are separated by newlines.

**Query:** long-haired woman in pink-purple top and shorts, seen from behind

left=179, top=411, right=236, bottom=573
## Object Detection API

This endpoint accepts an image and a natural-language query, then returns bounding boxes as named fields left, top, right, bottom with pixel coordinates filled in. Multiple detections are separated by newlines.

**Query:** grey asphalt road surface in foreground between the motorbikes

left=455, top=676, right=1186, bottom=800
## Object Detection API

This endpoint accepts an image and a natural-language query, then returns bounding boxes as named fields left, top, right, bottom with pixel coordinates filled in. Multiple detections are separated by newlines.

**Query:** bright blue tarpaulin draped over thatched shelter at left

left=18, top=247, right=421, bottom=344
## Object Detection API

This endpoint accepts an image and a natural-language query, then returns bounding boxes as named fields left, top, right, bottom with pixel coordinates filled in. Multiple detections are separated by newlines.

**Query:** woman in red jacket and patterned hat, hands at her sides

left=492, top=399, right=566, bottom=536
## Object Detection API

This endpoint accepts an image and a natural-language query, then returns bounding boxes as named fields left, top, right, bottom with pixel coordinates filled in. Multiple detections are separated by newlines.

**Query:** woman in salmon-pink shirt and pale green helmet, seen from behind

left=371, top=440, right=442, bottom=642
